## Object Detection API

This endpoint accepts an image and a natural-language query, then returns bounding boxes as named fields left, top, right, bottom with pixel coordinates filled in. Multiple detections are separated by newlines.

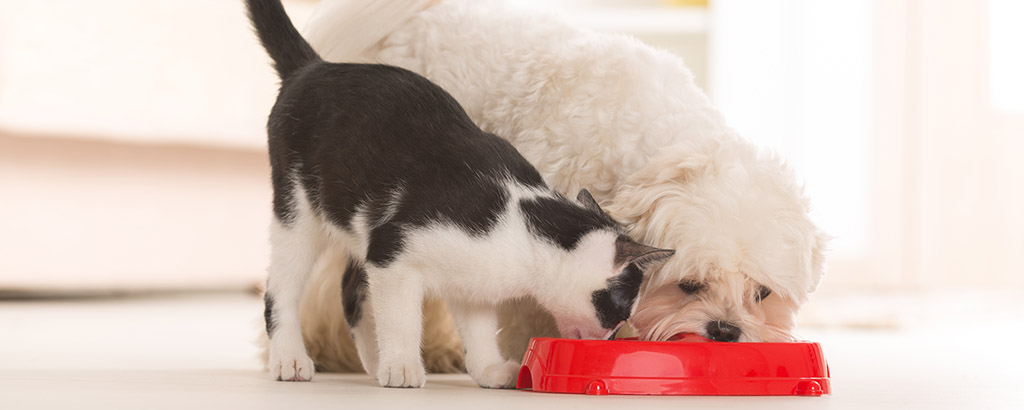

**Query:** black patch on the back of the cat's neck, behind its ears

left=519, top=197, right=616, bottom=251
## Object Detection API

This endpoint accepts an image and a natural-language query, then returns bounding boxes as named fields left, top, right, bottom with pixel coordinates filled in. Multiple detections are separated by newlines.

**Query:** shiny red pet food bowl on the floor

left=516, top=334, right=831, bottom=396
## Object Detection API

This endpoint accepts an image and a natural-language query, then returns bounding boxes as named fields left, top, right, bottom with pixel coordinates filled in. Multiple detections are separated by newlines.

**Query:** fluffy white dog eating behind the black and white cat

left=260, top=0, right=826, bottom=371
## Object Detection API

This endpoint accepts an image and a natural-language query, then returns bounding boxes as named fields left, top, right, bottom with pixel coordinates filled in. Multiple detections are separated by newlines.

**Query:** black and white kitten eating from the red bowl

left=247, top=0, right=674, bottom=387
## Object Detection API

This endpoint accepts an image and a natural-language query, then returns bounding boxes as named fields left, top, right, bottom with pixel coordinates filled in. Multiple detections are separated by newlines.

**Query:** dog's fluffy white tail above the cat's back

left=302, top=0, right=441, bottom=63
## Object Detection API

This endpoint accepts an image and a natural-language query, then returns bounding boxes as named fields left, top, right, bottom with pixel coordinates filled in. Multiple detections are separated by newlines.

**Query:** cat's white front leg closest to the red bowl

left=449, top=302, right=519, bottom=388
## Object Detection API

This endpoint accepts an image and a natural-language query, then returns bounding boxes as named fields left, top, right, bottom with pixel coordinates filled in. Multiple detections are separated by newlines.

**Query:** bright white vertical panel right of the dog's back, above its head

left=710, top=0, right=873, bottom=259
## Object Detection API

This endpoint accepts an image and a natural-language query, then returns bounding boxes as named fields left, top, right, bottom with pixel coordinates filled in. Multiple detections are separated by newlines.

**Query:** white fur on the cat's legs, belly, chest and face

left=267, top=179, right=624, bottom=387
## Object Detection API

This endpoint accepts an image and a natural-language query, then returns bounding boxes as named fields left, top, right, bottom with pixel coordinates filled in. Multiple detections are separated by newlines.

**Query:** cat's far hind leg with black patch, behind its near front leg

left=341, top=256, right=380, bottom=376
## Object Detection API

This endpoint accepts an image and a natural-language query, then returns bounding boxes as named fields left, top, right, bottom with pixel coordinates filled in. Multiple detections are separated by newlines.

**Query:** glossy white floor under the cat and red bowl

left=0, top=295, right=1024, bottom=410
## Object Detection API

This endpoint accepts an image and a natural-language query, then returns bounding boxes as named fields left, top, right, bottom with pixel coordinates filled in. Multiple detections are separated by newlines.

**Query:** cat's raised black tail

left=246, top=0, right=321, bottom=79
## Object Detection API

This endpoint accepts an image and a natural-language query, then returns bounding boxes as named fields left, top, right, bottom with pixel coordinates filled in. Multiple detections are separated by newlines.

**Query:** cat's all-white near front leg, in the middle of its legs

left=364, top=263, right=427, bottom=387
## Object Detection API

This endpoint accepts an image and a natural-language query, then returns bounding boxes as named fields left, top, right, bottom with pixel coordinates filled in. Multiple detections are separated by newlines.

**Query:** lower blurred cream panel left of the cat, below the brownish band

left=0, top=133, right=270, bottom=292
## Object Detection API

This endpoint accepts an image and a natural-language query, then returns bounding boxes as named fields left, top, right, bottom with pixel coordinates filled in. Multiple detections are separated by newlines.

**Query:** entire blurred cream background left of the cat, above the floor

left=0, top=0, right=314, bottom=291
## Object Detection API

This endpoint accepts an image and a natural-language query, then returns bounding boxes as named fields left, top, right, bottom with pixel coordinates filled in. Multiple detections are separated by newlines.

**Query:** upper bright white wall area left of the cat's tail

left=0, top=0, right=314, bottom=148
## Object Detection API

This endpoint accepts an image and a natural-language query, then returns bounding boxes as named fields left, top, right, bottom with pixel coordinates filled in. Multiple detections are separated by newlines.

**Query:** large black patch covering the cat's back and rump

left=267, top=63, right=552, bottom=265
